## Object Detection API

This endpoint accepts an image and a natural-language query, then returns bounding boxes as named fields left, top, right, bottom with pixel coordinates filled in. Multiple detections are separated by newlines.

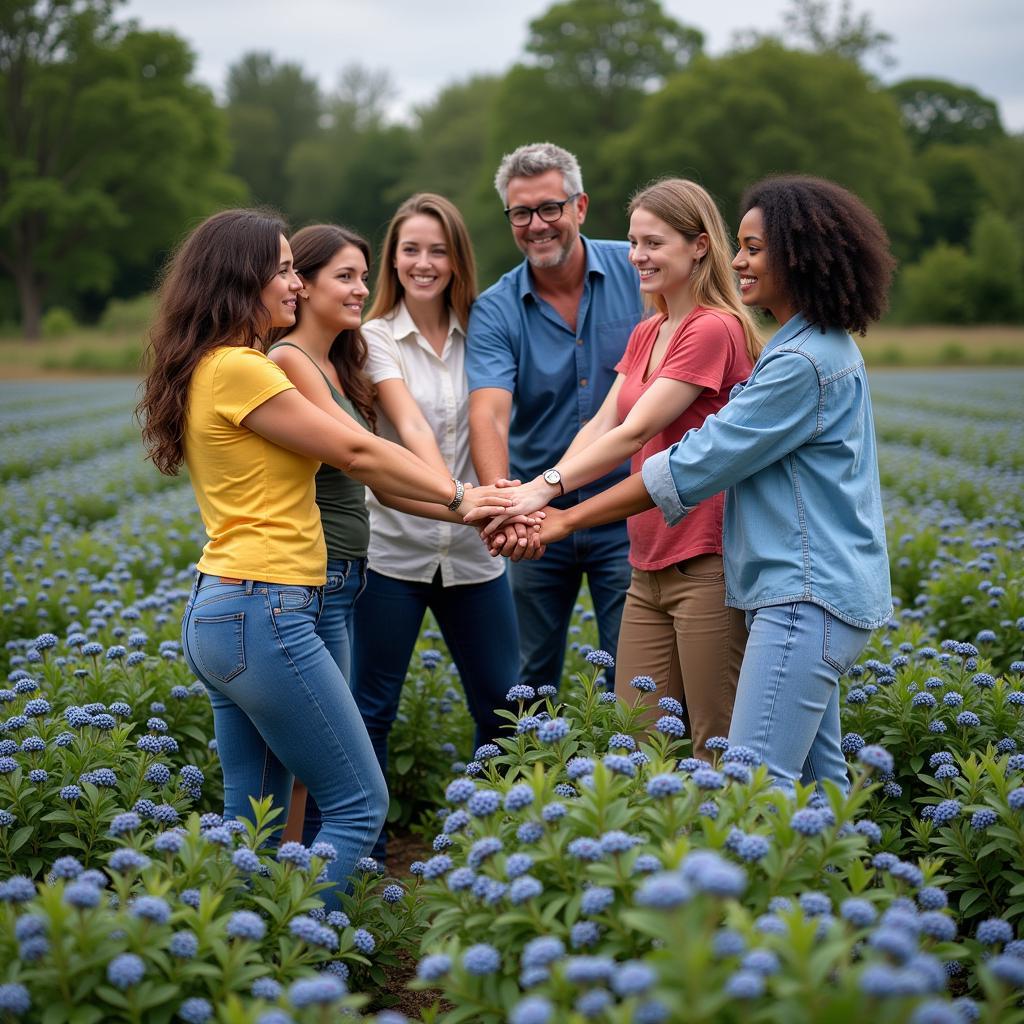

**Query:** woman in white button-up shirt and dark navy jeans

left=353, top=193, right=519, bottom=856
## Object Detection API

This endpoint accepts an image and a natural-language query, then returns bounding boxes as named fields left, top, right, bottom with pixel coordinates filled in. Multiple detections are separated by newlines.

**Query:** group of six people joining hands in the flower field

left=139, top=142, right=893, bottom=901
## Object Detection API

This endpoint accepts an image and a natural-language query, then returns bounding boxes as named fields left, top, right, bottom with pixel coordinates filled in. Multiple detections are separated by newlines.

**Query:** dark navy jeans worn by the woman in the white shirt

left=352, top=569, right=519, bottom=857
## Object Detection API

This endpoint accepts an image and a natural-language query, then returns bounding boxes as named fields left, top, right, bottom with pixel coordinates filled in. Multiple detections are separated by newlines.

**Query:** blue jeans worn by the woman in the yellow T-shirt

left=181, top=573, right=388, bottom=905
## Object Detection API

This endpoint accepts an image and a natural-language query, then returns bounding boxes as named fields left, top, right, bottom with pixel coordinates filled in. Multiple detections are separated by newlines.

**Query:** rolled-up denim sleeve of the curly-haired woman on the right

left=642, top=351, right=821, bottom=525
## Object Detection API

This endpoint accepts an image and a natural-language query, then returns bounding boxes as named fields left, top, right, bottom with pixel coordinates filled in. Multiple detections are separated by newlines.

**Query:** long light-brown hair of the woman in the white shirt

left=366, top=193, right=476, bottom=330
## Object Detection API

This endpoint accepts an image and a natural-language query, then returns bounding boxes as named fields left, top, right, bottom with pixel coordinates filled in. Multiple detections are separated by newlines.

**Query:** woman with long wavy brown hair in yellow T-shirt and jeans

left=138, top=210, right=512, bottom=902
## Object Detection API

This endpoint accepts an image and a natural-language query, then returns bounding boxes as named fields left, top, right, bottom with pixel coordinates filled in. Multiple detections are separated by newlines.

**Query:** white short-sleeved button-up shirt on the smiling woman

left=362, top=302, right=505, bottom=587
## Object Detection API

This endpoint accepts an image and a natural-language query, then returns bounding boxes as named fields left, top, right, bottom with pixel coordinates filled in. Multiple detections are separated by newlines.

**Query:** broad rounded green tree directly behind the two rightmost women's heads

left=603, top=41, right=928, bottom=249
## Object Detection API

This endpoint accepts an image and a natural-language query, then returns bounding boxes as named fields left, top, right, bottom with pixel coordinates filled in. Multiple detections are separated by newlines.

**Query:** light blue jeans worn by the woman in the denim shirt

left=729, top=601, right=871, bottom=793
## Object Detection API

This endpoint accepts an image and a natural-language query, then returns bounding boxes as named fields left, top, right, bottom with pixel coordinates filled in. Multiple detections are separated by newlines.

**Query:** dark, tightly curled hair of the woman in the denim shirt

left=739, top=175, right=896, bottom=335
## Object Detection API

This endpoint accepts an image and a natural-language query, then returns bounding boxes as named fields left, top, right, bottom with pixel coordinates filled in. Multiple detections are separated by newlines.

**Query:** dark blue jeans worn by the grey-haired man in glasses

left=509, top=522, right=632, bottom=686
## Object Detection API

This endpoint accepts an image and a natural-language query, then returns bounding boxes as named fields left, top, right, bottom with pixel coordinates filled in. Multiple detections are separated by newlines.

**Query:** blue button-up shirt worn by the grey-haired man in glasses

left=466, top=239, right=643, bottom=504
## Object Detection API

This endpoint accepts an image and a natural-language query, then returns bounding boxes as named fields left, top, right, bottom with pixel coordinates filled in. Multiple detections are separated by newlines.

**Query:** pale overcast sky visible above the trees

left=122, top=0, right=1024, bottom=131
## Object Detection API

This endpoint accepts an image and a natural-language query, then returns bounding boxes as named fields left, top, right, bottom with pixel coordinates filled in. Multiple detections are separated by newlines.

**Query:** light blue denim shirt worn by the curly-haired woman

left=642, top=314, right=892, bottom=629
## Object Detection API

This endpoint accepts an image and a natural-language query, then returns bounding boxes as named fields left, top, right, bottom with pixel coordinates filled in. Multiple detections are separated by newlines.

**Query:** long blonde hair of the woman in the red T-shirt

left=629, top=178, right=764, bottom=360
